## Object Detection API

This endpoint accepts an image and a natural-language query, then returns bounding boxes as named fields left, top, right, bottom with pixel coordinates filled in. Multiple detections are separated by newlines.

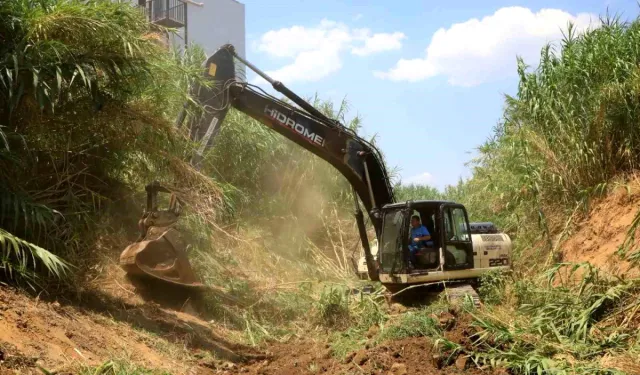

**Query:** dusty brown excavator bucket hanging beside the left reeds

left=120, top=182, right=203, bottom=287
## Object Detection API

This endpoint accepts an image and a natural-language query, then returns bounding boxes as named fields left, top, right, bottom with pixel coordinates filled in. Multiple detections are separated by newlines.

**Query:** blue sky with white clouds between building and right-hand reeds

left=242, top=0, right=639, bottom=188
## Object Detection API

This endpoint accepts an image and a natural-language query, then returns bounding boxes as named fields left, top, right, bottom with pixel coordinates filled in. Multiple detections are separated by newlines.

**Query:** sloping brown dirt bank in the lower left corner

left=0, top=287, right=264, bottom=375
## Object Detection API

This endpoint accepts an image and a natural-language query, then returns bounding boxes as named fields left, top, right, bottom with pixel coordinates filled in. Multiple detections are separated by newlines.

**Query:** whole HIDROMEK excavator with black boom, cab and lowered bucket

left=120, top=44, right=512, bottom=298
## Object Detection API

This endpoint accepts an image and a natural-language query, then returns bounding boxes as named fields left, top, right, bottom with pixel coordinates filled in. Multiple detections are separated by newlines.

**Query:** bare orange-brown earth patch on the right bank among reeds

left=561, top=179, right=640, bottom=274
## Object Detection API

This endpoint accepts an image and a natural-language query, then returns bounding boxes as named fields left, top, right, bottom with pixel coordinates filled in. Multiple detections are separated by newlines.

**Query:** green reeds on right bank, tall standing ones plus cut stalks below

left=336, top=12, right=640, bottom=374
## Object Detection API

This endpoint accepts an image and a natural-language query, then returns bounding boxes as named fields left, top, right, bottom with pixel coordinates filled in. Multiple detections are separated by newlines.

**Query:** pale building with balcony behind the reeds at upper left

left=133, top=0, right=246, bottom=64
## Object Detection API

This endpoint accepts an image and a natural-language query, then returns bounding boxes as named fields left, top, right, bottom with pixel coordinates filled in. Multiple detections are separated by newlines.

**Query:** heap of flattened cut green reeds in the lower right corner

left=440, top=265, right=640, bottom=374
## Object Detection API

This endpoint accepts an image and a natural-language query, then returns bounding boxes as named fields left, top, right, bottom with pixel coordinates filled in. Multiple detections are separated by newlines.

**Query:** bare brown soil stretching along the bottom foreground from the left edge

left=0, top=264, right=490, bottom=375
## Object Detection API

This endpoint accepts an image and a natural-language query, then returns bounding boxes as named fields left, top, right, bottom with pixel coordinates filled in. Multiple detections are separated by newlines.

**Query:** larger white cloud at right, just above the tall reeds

left=374, top=7, right=599, bottom=86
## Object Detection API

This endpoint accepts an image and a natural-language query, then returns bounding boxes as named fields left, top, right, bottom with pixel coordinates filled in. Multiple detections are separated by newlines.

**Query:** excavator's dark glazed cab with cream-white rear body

left=378, top=200, right=511, bottom=290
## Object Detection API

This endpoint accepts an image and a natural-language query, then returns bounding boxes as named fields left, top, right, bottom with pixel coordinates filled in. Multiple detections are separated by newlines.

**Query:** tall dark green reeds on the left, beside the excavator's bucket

left=0, top=0, right=212, bottom=281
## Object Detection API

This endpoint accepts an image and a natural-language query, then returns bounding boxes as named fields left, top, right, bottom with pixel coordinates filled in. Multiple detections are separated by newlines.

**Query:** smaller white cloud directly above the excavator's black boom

left=255, top=20, right=405, bottom=84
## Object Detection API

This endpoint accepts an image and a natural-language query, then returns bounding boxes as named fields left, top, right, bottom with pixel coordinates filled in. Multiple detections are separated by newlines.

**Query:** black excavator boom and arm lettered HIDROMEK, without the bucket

left=177, top=45, right=394, bottom=280
